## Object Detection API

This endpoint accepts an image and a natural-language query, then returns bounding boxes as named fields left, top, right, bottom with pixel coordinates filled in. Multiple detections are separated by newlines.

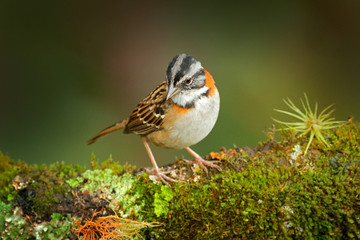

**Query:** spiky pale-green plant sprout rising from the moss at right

left=273, top=93, right=344, bottom=155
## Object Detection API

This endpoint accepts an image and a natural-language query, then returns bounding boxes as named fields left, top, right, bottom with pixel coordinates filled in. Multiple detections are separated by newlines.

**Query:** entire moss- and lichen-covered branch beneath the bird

left=0, top=121, right=360, bottom=239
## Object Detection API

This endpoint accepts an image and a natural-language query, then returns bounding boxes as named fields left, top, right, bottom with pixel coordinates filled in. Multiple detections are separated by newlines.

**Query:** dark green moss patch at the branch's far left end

left=0, top=152, right=82, bottom=219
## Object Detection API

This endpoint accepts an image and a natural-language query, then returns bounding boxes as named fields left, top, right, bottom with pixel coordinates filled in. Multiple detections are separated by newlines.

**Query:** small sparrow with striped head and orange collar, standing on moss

left=87, top=53, right=221, bottom=186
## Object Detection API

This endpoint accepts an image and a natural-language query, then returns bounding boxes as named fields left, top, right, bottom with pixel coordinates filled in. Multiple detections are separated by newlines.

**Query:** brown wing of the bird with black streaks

left=124, top=81, right=167, bottom=135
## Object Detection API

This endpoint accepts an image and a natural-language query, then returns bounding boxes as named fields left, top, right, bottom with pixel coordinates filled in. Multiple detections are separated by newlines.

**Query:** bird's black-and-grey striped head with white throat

left=166, top=53, right=213, bottom=108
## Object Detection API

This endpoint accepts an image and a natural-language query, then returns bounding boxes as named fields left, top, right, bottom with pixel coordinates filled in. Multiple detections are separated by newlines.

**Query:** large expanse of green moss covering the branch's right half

left=139, top=123, right=360, bottom=239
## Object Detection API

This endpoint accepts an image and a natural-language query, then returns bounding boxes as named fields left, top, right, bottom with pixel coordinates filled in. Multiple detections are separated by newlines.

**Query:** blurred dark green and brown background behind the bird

left=0, top=0, right=360, bottom=167
